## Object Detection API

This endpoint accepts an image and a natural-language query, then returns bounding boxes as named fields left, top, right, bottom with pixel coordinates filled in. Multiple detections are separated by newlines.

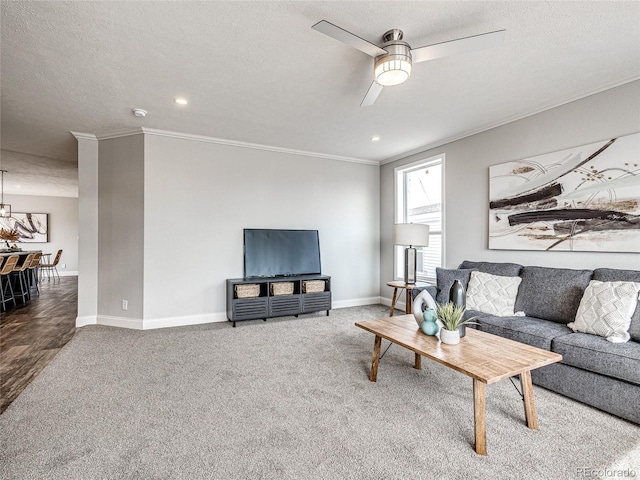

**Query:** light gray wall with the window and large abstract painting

left=380, top=81, right=640, bottom=297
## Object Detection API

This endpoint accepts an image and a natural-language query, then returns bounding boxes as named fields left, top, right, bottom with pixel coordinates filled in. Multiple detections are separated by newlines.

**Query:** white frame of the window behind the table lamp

left=393, top=153, right=446, bottom=284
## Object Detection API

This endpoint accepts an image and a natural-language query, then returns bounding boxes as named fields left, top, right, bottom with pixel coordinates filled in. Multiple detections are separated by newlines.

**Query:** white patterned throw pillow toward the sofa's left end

left=467, top=272, right=522, bottom=317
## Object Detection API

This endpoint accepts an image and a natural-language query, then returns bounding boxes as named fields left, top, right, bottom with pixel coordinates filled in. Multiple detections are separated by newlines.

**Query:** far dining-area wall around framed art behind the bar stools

left=4, top=195, right=78, bottom=275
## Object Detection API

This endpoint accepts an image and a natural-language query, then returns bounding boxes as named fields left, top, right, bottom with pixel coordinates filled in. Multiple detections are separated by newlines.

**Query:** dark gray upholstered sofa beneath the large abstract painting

left=413, top=261, right=640, bottom=424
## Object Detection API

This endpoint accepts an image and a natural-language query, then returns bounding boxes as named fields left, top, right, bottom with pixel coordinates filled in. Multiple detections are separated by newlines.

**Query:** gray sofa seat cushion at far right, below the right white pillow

left=551, top=333, right=640, bottom=385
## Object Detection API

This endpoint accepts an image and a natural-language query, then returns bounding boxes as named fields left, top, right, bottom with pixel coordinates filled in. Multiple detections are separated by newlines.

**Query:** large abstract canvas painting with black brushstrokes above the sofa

left=489, top=133, right=640, bottom=252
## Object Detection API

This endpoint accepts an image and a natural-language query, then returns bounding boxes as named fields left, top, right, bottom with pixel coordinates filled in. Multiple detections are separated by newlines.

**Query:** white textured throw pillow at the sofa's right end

left=567, top=280, right=640, bottom=343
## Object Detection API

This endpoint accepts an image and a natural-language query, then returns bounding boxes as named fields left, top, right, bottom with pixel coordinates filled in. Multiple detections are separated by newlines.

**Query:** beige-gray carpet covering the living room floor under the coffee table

left=0, top=306, right=640, bottom=480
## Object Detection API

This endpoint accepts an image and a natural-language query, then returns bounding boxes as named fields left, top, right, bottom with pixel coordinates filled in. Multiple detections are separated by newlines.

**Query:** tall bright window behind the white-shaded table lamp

left=394, top=154, right=444, bottom=282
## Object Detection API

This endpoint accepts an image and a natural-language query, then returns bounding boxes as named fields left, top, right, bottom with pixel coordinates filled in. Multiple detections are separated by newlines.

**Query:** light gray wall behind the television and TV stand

left=144, top=134, right=380, bottom=328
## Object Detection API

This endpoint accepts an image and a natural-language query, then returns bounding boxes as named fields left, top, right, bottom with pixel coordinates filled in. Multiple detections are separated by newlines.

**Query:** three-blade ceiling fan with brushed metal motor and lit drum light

left=311, top=20, right=506, bottom=107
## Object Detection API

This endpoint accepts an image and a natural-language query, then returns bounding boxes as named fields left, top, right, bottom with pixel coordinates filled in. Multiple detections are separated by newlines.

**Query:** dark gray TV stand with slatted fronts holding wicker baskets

left=227, top=275, right=331, bottom=327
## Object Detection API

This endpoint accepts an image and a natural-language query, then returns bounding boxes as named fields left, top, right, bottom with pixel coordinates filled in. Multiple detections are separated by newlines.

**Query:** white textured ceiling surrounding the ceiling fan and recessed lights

left=0, top=0, right=640, bottom=193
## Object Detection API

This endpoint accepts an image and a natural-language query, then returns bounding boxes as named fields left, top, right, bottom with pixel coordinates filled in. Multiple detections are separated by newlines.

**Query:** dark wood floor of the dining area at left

left=0, top=277, right=78, bottom=413
